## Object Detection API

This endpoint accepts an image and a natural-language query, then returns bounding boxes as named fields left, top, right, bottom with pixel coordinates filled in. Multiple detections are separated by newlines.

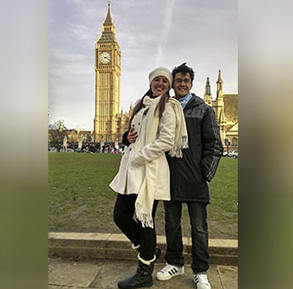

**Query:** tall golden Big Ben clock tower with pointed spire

left=94, top=1, right=121, bottom=142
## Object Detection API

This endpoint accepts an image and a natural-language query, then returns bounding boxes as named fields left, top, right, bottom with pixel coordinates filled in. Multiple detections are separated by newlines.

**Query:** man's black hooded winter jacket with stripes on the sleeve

left=167, top=94, right=223, bottom=203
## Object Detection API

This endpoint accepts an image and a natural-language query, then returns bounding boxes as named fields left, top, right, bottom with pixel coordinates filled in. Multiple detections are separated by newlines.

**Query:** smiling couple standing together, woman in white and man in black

left=110, top=63, right=222, bottom=289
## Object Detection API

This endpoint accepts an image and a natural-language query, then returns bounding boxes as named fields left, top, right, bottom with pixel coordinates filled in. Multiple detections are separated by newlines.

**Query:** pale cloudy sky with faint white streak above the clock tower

left=48, top=0, right=238, bottom=130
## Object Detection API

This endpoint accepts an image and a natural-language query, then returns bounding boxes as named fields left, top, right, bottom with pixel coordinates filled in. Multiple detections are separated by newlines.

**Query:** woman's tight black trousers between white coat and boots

left=114, top=194, right=158, bottom=260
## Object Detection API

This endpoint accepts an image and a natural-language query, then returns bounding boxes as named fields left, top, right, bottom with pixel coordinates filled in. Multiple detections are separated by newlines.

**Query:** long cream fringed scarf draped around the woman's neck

left=135, top=96, right=188, bottom=228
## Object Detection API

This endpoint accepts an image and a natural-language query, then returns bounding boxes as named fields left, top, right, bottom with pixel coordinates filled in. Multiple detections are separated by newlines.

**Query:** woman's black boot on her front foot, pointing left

left=118, top=261, right=154, bottom=289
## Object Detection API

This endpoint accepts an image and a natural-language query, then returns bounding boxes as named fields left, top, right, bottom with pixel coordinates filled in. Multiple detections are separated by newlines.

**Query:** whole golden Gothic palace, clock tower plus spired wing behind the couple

left=94, top=2, right=238, bottom=148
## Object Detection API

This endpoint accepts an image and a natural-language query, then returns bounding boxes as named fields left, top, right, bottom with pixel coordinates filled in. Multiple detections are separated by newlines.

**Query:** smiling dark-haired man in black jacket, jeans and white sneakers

left=156, top=63, right=223, bottom=289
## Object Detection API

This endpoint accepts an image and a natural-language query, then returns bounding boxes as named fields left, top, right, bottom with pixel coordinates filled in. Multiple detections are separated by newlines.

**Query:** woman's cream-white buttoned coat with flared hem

left=110, top=96, right=176, bottom=201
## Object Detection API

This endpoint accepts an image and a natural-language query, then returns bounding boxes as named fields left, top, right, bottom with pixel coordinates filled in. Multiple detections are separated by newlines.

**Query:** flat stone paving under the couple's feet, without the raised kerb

left=48, top=257, right=238, bottom=289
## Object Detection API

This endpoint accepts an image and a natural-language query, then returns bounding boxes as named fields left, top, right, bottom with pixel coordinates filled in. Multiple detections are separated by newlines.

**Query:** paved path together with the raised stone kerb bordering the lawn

left=48, top=232, right=238, bottom=289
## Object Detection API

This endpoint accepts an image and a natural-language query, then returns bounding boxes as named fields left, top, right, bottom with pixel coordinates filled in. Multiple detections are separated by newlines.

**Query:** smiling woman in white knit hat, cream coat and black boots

left=110, top=67, right=187, bottom=289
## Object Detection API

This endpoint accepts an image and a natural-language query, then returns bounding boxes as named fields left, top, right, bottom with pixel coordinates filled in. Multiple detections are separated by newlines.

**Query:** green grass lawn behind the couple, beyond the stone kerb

left=48, top=153, right=238, bottom=239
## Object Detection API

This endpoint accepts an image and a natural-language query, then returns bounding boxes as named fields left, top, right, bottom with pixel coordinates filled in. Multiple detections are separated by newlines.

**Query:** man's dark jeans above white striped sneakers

left=164, top=201, right=209, bottom=273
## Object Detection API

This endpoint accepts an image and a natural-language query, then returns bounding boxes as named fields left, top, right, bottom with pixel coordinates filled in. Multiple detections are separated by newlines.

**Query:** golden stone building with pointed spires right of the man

left=204, top=70, right=238, bottom=148
